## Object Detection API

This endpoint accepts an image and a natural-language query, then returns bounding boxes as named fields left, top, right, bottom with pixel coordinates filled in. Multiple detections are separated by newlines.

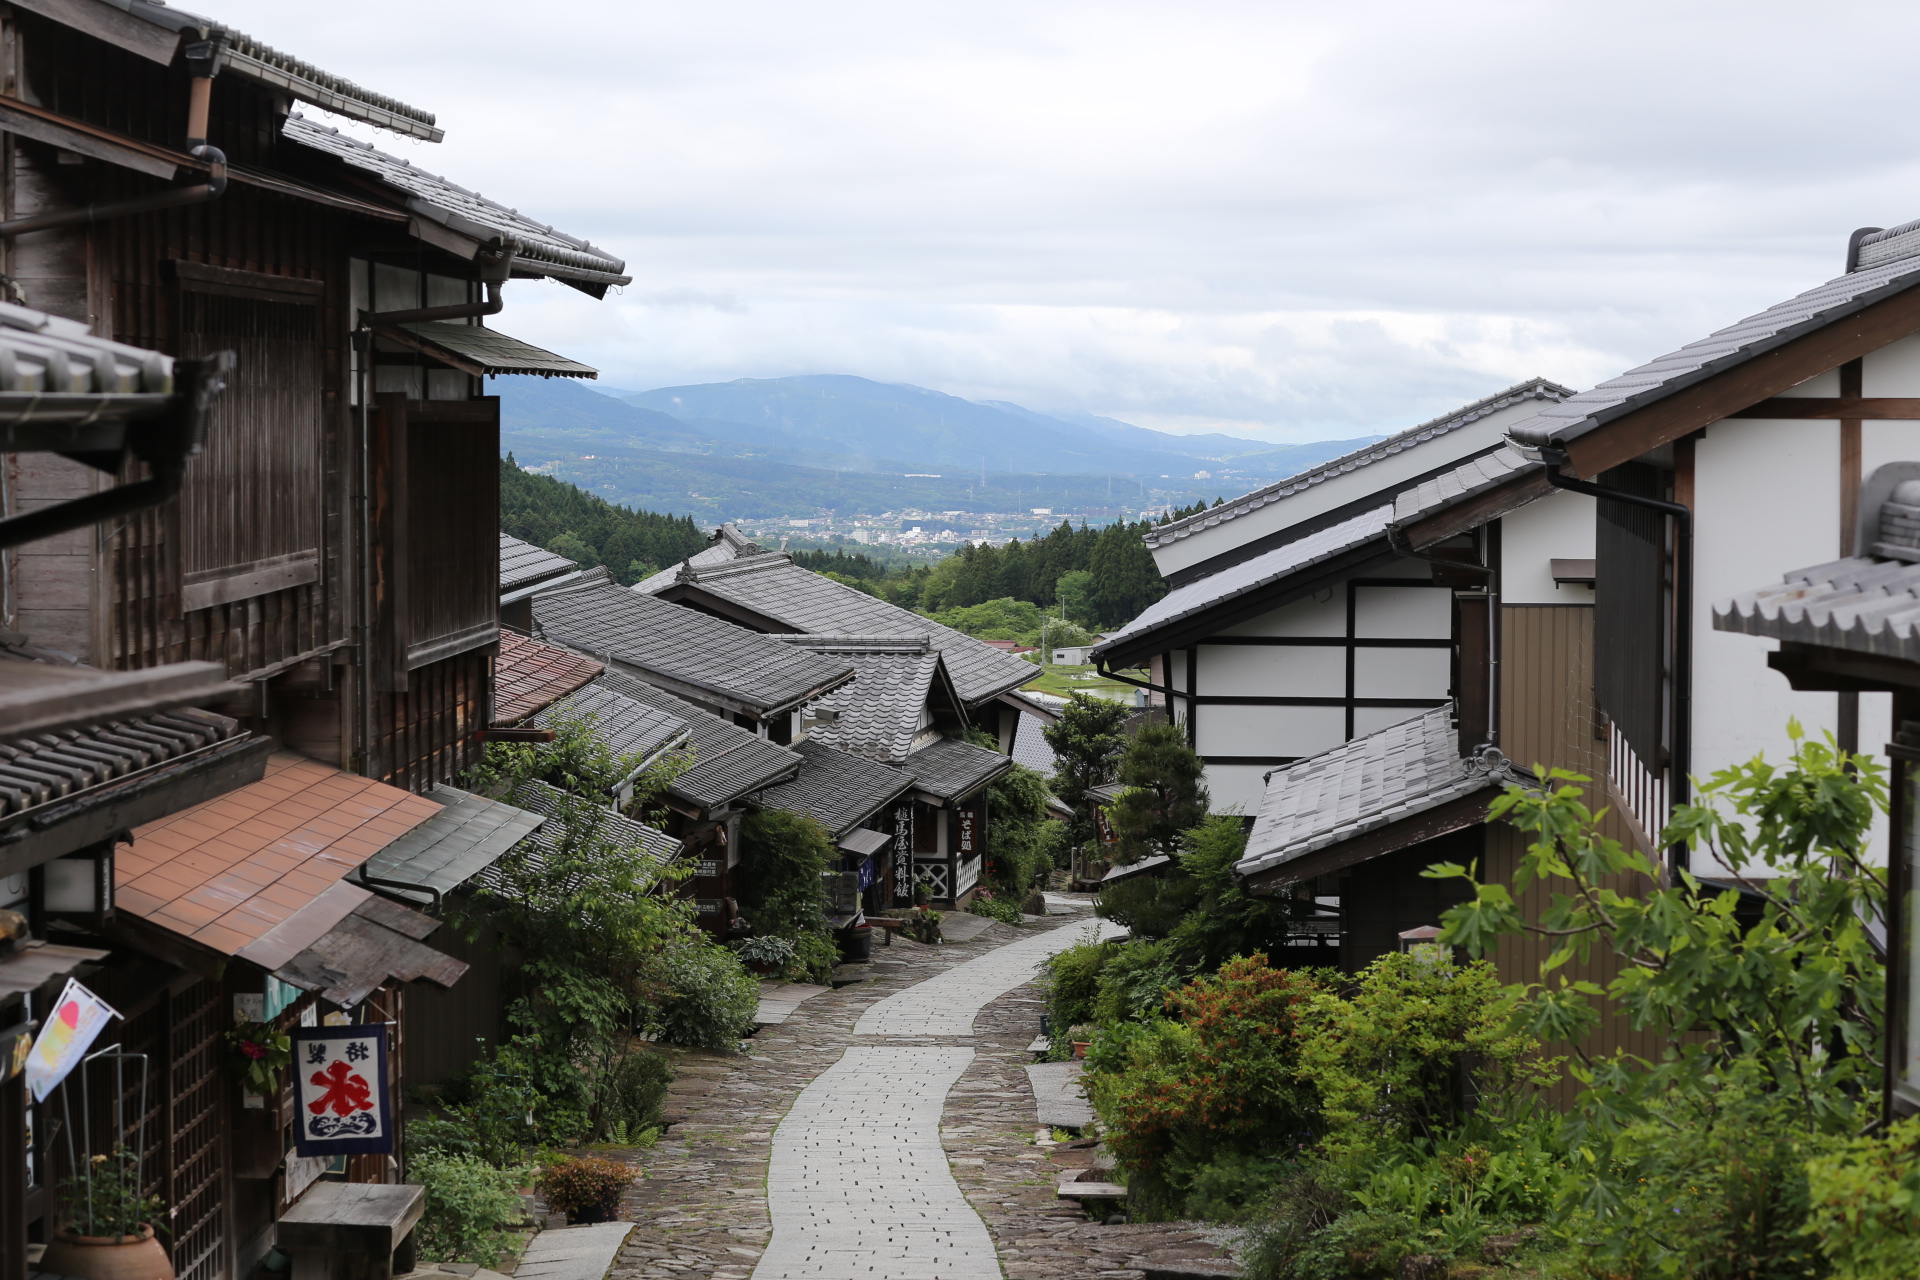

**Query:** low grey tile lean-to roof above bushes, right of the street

left=1233, top=702, right=1528, bottom=875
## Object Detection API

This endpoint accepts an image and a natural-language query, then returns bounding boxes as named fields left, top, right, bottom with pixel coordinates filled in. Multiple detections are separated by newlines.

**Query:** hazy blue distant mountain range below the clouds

left=488, top=374, right=1379, bottom=520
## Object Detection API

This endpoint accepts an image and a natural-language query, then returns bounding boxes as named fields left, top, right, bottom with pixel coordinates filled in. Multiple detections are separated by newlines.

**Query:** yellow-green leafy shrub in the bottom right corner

left=1807, top=1119, right=1920, bottom=1280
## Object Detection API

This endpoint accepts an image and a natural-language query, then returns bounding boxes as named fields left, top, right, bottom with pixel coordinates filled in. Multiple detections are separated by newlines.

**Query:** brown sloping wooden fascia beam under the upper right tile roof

left=1567, top=286, right=1920, bottom=478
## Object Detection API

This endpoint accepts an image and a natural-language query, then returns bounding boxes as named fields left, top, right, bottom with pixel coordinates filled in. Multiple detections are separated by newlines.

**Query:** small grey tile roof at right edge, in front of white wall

left=1713, top=557, right=1920, bottom=662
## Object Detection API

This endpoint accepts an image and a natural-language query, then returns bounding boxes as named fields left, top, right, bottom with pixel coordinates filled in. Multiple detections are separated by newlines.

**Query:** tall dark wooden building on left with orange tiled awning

left=0, top=0, right=626, bottom=1280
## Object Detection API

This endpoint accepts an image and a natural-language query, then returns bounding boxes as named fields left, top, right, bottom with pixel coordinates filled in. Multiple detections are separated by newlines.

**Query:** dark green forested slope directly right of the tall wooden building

left=499, top=453, right=707, bottom=583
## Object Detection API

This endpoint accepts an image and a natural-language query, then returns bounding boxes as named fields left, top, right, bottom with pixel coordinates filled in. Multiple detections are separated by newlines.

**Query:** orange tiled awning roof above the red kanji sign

left=113, top=752, right=440, bottom=969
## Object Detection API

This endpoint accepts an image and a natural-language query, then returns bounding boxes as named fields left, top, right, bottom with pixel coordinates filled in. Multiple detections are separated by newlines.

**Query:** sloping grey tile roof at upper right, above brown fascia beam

left=1507, top=249, right=1920, bottom=445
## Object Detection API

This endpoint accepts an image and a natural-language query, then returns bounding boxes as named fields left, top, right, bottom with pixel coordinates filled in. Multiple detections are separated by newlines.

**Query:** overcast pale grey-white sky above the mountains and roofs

left=214, top=0, right=1920, bottom=439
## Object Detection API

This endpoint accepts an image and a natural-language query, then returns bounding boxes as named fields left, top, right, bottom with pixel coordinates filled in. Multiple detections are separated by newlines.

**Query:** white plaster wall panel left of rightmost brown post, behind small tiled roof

left=1692, top=418, right=1864, bottom=840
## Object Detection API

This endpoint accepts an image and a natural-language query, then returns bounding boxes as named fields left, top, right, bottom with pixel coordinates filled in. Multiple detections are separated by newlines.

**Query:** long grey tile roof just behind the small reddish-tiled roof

left=534, top=583, right=852, bottom=714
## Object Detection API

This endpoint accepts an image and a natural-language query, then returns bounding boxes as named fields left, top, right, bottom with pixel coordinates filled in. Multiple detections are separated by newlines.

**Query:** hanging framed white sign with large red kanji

left=294, top=1023, right=394, bottom=1155
